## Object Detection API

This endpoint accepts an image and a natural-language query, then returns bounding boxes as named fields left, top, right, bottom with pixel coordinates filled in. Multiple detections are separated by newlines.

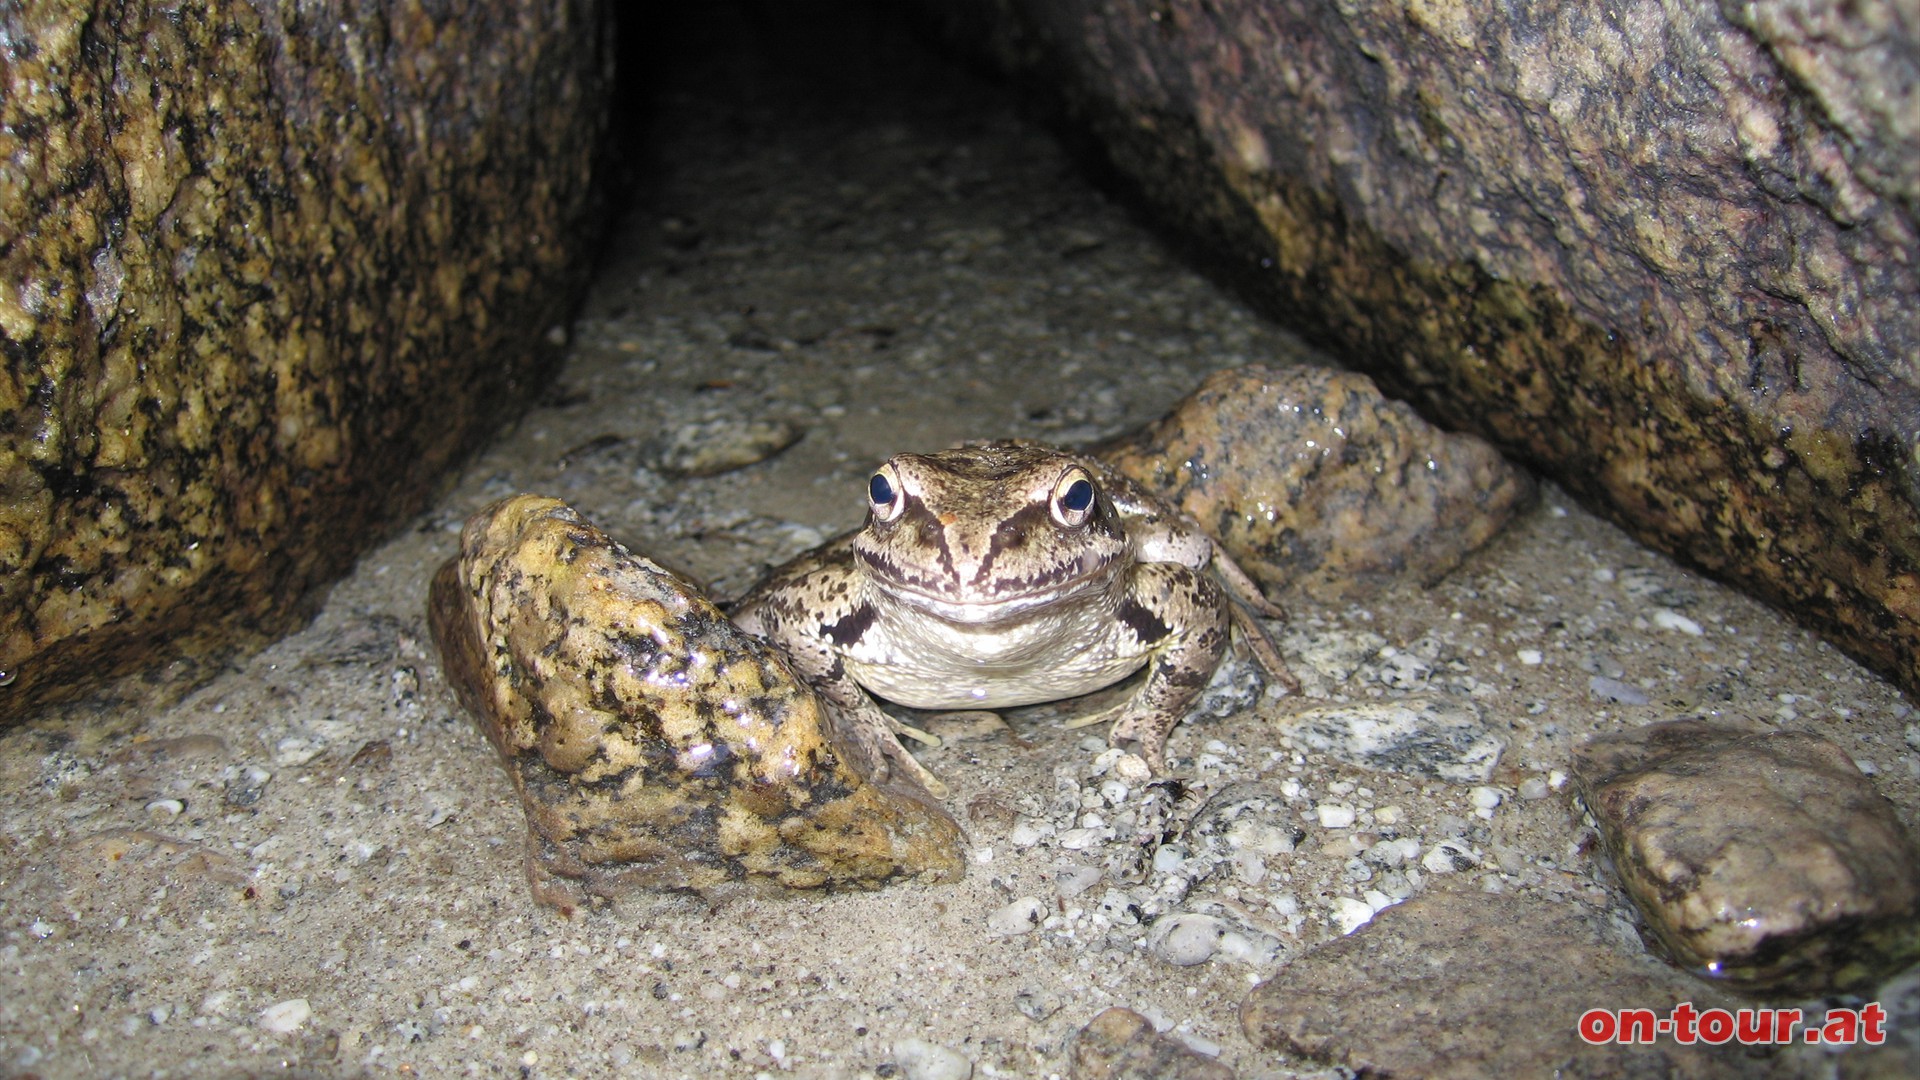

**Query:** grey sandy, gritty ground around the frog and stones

left=0, top=6, right=1920, bottom=1076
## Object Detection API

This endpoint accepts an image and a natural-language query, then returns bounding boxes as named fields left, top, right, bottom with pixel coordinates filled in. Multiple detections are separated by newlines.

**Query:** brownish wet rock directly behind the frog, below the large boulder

left=1100, top=365, right=1534, bottom=600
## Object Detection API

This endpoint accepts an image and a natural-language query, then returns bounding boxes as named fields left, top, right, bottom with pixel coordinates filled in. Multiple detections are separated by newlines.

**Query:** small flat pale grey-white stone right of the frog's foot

left=1277, top=696, right=1507, bottom=784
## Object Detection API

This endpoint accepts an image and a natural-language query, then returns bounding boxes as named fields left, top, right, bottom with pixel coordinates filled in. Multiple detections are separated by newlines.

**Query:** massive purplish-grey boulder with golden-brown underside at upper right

left=924, top=0, right=1920, bottom=692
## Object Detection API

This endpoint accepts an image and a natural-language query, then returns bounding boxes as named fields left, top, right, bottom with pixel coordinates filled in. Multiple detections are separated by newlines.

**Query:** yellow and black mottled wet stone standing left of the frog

left=428, top=496, right=964, bottom=907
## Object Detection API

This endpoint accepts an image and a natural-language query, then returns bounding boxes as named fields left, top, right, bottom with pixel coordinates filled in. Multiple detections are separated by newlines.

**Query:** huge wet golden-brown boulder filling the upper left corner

left=0, top=0, right=607, bottom=719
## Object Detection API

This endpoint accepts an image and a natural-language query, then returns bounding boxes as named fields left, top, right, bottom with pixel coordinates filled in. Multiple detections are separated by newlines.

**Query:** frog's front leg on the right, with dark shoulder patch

left=1069, top=563, right=1231, bottom=773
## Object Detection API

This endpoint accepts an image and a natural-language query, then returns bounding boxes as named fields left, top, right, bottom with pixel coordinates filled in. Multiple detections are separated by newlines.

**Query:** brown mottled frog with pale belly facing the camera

left=730, top=440, right=1300, bottom=796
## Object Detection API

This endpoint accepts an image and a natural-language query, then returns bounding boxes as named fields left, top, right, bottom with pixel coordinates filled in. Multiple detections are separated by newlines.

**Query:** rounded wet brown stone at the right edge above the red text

left=1574, top=721, right=1920, bottom=995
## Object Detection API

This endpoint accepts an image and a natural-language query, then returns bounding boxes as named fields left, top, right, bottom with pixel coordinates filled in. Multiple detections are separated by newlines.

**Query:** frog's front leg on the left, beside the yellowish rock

left=732, top=578, right=947, bottom=798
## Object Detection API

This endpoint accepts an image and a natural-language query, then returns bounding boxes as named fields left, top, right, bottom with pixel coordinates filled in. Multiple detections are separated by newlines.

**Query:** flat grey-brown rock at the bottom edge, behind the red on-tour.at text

left=1240, top=888, right=1763, bottom=1080
